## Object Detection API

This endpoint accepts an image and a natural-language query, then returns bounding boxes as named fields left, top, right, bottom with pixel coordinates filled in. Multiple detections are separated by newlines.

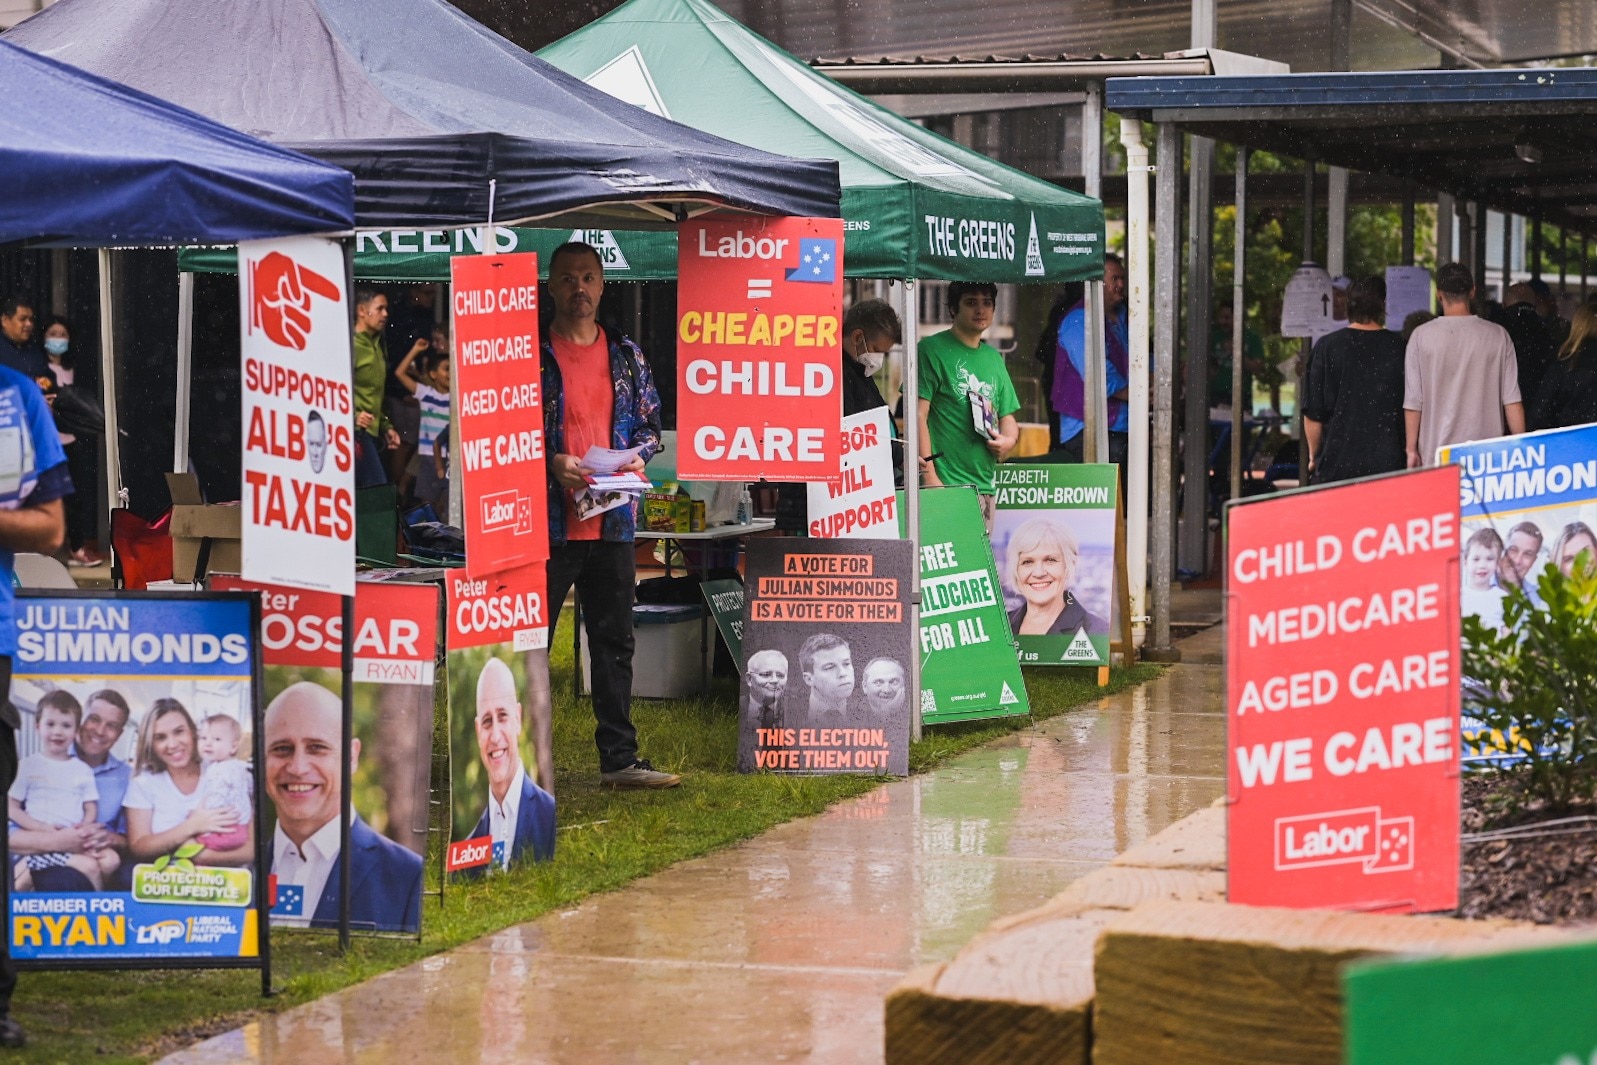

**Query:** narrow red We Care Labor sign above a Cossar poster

left=449, top=252, right=549, bottom=576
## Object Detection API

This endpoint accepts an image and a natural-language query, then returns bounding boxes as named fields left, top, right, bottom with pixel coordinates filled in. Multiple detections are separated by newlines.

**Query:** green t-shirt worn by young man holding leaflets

left=920, top=329, right=1020, bottom=495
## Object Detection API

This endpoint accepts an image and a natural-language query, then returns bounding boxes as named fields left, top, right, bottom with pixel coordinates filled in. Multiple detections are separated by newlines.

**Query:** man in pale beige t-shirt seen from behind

left=1402, top=262, right=1525, bottom=468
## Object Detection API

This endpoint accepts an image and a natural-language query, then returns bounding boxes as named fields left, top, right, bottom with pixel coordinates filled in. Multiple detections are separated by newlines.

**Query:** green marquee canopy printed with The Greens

left=184, top=0, right=1104, bottom=283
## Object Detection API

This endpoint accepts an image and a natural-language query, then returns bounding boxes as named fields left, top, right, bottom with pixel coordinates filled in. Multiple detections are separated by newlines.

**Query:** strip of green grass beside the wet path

left=5, top=638, right=1159, bottom=1062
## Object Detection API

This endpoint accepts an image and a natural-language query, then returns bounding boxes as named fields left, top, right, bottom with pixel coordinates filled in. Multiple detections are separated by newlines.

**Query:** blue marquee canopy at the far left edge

left=0, top=42, right=355, bottom=247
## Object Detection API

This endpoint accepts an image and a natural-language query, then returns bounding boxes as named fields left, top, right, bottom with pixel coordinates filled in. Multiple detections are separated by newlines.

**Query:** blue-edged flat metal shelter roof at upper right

left=1105, top=67, right=1597, bottom=232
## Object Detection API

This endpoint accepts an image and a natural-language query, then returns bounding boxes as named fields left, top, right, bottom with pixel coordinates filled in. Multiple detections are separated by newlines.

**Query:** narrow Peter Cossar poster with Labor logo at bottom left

left=444, top=564, right=554, bottom=875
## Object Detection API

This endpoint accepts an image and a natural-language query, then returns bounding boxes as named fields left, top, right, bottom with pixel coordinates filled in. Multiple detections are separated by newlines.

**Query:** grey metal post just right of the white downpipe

left=1151, top=121, right=1182, bottom=651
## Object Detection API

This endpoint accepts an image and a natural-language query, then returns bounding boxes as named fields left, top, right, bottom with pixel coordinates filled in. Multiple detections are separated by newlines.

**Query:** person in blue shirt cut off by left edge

left=0, top=351, right=72, bottom=1047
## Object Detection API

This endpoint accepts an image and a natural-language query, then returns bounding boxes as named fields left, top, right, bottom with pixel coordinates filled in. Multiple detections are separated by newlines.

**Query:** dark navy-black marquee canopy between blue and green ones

left=3, top=0, right=840, bottom=228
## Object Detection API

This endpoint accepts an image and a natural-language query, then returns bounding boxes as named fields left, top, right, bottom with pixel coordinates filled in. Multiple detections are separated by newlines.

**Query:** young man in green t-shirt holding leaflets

left=918, top=281, right=1020, bottom=532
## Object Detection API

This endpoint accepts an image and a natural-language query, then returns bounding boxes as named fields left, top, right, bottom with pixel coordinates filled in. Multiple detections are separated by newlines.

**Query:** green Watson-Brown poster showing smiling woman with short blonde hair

left=992, top=463, right=1119, bottom=666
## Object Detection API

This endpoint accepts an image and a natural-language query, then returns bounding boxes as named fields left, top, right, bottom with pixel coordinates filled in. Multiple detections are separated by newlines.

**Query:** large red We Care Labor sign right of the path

left=1225, top=466, right=1460, bottom=912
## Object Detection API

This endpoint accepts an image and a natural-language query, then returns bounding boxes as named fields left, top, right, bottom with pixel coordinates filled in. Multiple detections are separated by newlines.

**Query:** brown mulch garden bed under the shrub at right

left=1458, top=774, right=1597, bottom=924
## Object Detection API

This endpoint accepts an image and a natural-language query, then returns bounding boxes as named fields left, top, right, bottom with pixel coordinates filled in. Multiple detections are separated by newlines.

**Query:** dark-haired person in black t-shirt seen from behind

left=1303, top=278, right=1404, bottom=484
